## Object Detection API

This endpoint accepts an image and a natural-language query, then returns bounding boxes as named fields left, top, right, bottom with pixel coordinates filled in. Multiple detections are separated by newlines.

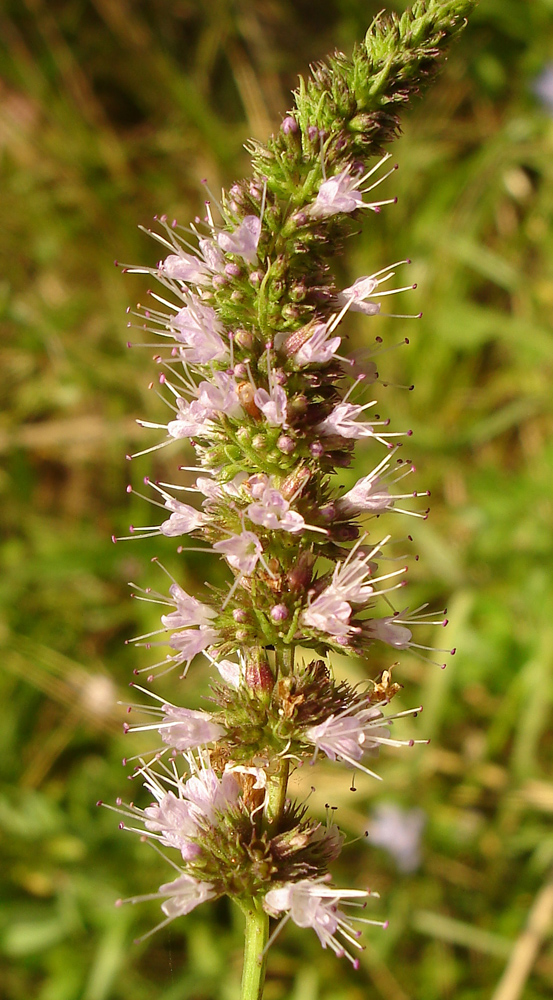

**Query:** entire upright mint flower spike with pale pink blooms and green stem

left=103, top=0, right=473, bottom=1000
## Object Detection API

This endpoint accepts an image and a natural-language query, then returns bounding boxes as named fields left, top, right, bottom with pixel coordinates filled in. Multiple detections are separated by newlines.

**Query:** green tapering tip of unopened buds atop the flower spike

left=251, top=0, right=476, bottom=197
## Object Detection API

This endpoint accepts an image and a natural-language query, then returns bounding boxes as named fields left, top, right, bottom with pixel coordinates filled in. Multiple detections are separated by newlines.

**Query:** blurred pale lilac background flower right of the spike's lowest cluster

left=367, top=802, right=426, bottom=874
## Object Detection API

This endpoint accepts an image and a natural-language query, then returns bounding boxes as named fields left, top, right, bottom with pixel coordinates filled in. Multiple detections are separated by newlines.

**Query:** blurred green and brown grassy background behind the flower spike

left=0, top=0, right=553, bottom=1000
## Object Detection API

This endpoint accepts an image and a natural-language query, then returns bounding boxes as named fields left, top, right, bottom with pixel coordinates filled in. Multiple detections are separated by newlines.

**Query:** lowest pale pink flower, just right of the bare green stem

left=263, top=879, right=376, bottom=968
